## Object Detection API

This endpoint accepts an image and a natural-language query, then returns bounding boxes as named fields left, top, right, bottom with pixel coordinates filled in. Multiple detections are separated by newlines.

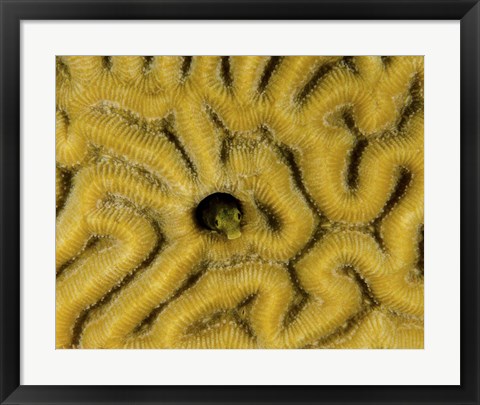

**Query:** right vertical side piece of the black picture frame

left=460, top=3, right=480, bottom=404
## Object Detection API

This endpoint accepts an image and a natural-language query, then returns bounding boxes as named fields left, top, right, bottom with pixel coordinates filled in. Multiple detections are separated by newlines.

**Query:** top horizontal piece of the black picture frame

left=2, top=0, right=478, bottom=20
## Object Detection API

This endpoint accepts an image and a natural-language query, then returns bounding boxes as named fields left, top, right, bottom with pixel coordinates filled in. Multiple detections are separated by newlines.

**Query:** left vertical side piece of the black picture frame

left=0, top=1, right=20, bottom=402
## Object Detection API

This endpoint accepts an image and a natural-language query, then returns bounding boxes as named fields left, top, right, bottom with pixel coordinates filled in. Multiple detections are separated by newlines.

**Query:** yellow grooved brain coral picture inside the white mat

left=56, top=56, right=424, bottom=349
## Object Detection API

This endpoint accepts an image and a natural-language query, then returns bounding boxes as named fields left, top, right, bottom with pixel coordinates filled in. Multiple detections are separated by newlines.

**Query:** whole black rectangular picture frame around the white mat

left=0, top=0, right=480, bottom=405
